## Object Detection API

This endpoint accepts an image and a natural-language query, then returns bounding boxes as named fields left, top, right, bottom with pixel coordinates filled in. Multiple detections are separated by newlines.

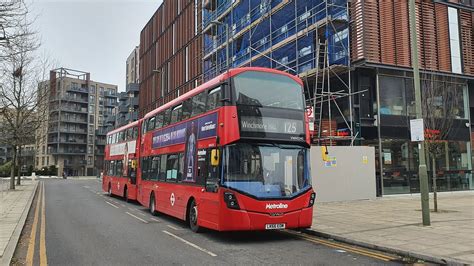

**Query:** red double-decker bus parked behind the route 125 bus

left=102, top=121, right=141, bottom=200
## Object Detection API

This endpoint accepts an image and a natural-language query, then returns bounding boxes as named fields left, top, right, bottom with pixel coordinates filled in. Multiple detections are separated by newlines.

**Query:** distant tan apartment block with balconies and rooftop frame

left=36, top=68, right=117, bottom=176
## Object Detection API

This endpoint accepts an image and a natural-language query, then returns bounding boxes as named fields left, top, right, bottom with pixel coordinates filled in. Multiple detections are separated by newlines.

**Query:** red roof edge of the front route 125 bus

left=143, top=67, right=303, bottom=119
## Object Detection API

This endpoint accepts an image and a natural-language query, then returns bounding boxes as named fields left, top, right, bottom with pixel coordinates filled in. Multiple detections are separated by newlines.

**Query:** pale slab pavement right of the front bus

left=311, top=191, right=474, bottom=264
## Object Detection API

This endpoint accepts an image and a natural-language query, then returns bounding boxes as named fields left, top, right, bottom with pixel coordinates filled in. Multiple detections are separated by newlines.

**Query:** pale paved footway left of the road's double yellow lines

left=0, top=178, right=38, bottom=265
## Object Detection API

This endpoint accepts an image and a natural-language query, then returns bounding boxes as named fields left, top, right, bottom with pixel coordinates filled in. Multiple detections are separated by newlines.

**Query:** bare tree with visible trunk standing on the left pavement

left=0, top=25, right=51, bottom=189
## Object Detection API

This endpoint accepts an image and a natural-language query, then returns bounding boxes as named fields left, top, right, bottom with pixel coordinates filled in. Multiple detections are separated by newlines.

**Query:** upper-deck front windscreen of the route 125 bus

left=233, top=71, right=304, bottom=110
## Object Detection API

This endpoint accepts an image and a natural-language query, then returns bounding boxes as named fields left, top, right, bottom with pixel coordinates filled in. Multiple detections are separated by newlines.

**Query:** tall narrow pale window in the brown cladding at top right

left=448, top=7, right=462, bottom=74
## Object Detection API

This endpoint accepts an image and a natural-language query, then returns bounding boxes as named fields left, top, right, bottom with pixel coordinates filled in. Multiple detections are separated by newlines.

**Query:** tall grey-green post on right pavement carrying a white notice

left=410, top=0, right=431, bottom=226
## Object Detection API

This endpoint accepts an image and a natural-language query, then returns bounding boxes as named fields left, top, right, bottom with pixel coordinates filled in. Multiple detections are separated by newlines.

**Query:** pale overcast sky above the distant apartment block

left=30, top=0, right=162, bottom=91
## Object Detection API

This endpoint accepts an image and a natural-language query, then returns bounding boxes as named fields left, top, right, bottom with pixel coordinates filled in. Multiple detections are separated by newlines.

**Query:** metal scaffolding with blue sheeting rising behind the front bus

left=203, top=0, right=354, bottom=144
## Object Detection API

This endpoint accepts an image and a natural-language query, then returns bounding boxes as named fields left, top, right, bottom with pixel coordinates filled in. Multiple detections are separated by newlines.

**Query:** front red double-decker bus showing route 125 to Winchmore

left=135, top=68, right=315, bottom=231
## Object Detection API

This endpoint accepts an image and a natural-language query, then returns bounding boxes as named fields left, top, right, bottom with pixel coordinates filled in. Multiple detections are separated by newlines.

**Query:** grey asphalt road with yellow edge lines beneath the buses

left=13, top=180, right=408, bottom=265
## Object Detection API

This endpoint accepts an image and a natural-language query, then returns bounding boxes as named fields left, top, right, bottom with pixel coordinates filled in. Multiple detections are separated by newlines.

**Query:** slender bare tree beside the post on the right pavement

left=421, top=73, right=464, bottom=212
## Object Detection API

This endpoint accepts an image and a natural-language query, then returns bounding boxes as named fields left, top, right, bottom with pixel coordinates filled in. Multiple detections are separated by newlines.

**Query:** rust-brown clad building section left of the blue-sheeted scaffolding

left=139, top=0, right=202, bottom=117
